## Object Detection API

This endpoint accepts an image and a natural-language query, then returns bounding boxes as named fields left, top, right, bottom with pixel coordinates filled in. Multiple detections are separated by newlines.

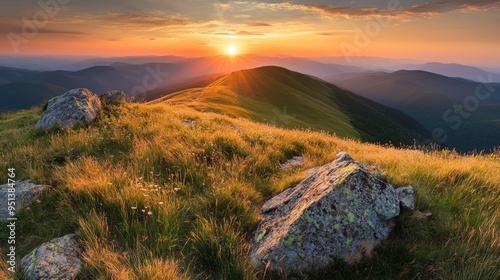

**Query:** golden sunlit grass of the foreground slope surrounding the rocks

left=0, top=104, right=500, bottom=279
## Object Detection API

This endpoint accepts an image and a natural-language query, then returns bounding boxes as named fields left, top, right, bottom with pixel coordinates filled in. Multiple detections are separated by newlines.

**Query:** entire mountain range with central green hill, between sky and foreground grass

left=0, top=55, right=500, bottom=152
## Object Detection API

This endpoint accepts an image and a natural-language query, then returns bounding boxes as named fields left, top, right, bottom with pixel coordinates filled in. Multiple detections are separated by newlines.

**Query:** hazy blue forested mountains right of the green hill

left=328, top=70, right=500, bottom=151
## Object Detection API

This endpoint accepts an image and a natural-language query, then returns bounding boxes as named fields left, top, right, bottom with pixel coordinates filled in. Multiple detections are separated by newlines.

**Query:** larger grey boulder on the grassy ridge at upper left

left=35, top=88, right=101, bottom=129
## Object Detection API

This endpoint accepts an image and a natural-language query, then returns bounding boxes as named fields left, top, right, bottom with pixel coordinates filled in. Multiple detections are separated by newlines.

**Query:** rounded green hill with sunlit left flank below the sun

left=151, top=66, right=427, bottom=145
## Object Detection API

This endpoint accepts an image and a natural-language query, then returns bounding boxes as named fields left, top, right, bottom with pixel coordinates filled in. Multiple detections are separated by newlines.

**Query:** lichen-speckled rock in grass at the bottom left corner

left=21, top=234, right=82, bottom=280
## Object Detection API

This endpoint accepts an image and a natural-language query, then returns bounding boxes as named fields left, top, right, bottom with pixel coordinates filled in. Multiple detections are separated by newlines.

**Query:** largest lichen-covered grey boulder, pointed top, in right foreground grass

left=250, top=153, right=400, bottom=273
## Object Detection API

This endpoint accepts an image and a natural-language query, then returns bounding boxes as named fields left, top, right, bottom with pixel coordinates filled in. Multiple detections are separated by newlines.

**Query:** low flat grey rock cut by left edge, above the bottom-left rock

left=0, top=180, right=50, bottom=222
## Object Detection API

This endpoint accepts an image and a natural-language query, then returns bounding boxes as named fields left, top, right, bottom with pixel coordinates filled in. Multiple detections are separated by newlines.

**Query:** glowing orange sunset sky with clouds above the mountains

left=0, top=0, right=500, bottom=66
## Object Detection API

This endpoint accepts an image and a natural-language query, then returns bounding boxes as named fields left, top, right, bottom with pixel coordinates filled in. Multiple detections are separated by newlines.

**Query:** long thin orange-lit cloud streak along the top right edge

left=259, top=0, right=500, bottom=19
